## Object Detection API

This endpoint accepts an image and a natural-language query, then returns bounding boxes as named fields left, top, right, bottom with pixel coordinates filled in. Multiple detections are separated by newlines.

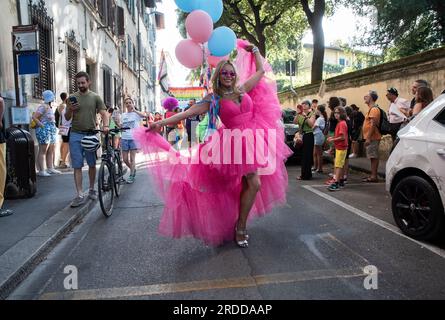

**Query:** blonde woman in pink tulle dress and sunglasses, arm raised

left=134, top=40, right=292, bottom=248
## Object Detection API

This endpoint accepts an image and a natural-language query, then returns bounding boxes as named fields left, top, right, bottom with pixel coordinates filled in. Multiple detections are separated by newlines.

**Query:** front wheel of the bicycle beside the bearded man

left=98, top=162, right=114, bottom=218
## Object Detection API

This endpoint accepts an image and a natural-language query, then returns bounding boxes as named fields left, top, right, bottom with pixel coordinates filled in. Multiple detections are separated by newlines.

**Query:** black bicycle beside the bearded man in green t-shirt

left=94, top=128, right=130, bottom=218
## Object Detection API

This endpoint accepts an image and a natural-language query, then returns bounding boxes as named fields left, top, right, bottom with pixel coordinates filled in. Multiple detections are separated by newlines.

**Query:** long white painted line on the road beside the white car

left=302, top=185, right=445, bottom=258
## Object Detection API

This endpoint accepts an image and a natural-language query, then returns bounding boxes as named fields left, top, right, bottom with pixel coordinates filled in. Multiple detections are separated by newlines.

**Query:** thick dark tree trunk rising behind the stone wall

left=300, top=0, right=326, bottom=83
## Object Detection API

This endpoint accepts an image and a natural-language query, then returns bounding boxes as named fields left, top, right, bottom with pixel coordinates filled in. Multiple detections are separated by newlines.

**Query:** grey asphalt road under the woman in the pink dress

left=10, top=161, right=445, bottom=300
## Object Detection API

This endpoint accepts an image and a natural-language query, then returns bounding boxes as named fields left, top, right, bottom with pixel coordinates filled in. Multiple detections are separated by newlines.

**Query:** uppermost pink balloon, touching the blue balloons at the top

left=185, top=10, right=213, bottom=43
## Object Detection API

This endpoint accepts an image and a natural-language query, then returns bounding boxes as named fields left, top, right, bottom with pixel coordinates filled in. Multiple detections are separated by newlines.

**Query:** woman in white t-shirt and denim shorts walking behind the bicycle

left=121, top=97, right=146, bottom=183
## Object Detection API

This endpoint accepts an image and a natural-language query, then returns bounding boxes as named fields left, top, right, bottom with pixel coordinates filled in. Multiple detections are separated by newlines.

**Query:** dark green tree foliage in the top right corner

left=342, top=0, right=445, bottom=60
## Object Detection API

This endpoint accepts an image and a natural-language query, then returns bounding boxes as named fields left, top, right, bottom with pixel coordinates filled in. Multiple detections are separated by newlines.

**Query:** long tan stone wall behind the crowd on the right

left=278, top=47, right=445, bottom=110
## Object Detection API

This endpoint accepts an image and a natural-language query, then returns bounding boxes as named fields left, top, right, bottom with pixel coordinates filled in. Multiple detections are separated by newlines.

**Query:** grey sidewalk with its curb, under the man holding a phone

left=0, top=168, right=97, bottom=299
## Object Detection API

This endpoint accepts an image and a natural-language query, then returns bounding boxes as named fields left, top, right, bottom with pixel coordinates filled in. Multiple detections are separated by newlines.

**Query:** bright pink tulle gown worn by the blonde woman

left=134, top=42, right=292, bottom=245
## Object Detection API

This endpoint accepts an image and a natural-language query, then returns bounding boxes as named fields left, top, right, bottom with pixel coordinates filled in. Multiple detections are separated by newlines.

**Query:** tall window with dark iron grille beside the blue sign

left=29, top=1, right=55, bottom=99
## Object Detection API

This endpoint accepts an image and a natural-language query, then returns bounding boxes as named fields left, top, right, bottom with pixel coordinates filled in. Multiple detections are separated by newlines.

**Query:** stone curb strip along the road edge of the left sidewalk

left=0, top=195, right=98, bottom=300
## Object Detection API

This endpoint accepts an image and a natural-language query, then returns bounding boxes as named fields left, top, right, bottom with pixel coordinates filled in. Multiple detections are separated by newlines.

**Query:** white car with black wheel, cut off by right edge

left=386, top=94, right=445, bottom=240
